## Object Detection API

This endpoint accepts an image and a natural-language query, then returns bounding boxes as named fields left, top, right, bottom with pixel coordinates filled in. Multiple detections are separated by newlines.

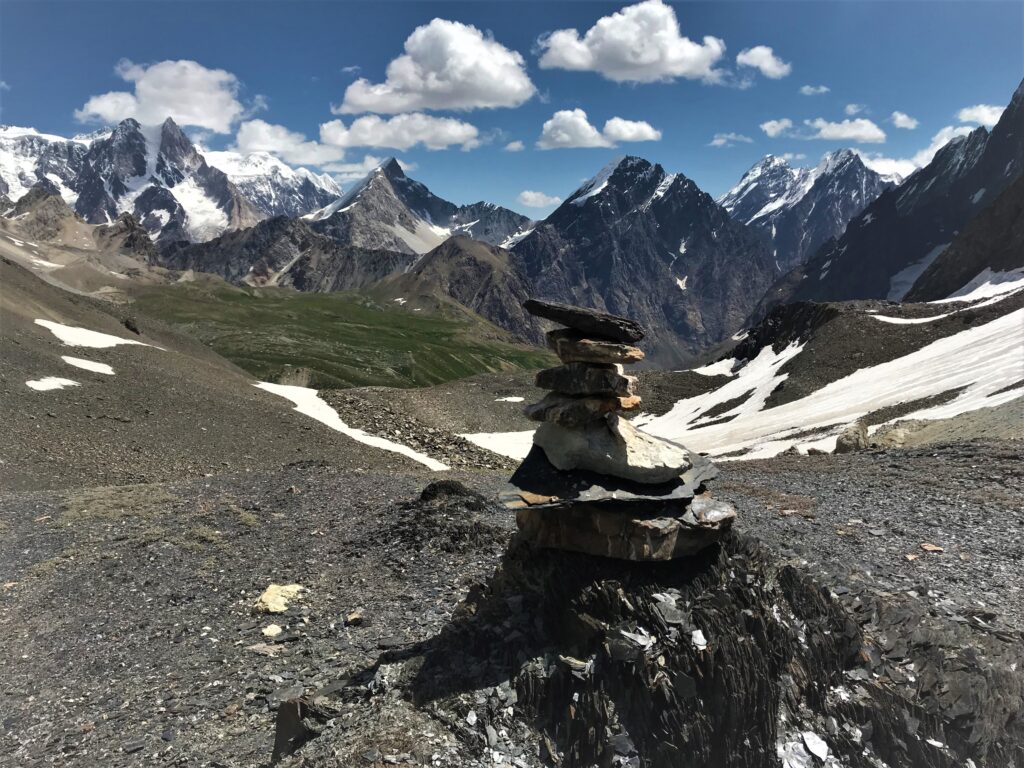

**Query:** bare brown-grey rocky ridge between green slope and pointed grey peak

left=160, top=216, right=413, bottom=292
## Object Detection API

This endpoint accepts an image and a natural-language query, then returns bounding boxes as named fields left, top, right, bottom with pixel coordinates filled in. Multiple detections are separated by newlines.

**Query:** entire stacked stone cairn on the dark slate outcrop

left=501, top=299, right=736, bottom=560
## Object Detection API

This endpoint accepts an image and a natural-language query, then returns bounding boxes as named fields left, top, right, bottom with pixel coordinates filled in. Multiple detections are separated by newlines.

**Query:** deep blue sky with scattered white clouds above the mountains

left=0, top=0, right=1024, bottom=216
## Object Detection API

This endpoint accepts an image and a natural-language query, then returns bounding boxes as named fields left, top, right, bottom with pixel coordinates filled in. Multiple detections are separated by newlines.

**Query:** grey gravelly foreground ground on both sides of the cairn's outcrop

left=0, top=441, right=1024, bottom=766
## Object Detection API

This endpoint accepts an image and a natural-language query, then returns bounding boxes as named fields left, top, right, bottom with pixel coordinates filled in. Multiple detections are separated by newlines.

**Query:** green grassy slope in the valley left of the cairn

left=135, top=279, right=553, bottom=388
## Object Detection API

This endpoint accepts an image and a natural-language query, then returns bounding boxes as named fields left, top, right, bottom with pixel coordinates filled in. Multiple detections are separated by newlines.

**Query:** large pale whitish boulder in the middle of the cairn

left=534, top=414, right=690, bottom=483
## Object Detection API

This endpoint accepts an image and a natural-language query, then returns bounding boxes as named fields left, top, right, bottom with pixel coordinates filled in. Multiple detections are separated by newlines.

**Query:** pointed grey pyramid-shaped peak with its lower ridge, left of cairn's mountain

left=305, top=158, right=529, bottom=254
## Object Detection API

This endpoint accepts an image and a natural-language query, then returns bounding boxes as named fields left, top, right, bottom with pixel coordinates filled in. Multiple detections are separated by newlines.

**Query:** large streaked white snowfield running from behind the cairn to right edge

left=461, top=309, right=1024, bottom=460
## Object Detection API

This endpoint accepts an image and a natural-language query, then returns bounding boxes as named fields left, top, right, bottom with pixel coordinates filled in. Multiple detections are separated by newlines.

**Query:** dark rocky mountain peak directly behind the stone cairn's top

left=507, top=157, right=780, bottom=364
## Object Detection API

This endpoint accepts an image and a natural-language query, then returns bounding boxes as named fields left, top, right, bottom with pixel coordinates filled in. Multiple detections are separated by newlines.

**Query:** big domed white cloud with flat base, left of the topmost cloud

left=332, top=18, right=537, bottom=115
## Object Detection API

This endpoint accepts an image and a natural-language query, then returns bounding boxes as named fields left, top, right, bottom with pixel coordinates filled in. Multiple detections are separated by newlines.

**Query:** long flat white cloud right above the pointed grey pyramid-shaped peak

left=321, top=112, right=480, bottom=150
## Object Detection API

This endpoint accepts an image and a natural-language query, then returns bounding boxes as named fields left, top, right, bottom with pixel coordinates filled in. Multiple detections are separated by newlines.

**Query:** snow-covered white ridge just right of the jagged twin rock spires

left=200, top=148, right=341, bottom=216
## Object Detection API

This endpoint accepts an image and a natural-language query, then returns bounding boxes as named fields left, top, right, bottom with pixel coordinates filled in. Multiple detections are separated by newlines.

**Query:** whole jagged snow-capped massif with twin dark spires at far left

left=0, top=119, right=341, bottom=243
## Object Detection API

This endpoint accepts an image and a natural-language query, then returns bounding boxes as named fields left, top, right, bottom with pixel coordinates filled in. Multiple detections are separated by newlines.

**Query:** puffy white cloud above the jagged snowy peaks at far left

left=75, top=58, right=256, bottom=133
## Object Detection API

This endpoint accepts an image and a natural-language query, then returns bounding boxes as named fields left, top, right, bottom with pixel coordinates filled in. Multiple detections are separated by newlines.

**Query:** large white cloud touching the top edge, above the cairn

left=538, top=0, right=725, bottom=83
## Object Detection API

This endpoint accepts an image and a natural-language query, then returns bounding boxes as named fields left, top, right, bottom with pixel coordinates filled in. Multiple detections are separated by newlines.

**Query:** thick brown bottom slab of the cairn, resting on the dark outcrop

left=516, top=496, right=736, bottom=561
